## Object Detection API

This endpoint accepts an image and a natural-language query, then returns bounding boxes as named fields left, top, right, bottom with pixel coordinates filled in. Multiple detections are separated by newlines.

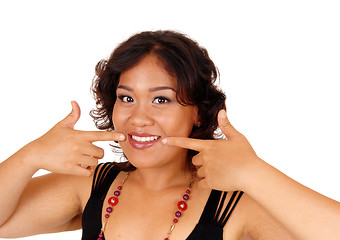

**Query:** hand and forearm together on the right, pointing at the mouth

left=163, top=110, right=340, bottom=240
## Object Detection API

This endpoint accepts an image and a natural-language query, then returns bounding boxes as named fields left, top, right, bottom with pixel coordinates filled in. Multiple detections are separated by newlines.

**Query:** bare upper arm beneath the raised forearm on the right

left=231, top=194, right=293, bottom=240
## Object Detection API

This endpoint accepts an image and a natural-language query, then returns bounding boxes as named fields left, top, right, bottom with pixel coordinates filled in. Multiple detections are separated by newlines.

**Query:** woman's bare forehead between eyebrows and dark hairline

left=119, top=54, right=177, bottom=89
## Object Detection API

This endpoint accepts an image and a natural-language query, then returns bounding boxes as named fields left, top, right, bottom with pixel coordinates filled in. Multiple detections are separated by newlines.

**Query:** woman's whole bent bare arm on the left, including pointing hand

left=0, top=102, right=125, bottom=237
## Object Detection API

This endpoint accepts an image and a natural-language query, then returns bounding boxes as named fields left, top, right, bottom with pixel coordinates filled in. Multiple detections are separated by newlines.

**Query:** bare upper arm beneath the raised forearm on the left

left=0, top=174, right=91, bottom=238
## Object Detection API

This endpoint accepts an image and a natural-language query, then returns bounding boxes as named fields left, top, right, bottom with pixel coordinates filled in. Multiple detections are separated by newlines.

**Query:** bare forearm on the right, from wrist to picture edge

left=245, top=161, right=340, bottom=240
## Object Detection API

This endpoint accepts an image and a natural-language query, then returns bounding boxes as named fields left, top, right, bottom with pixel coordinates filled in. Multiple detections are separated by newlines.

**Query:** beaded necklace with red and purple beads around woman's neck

left=97, top=172, right=194, bottom=240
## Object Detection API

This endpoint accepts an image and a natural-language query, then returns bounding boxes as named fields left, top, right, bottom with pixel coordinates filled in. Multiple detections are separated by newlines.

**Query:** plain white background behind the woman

left=0, top=0, right=340, bottom=240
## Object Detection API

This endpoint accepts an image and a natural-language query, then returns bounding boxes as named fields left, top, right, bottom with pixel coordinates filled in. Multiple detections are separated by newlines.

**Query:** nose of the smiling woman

left=130, top=104, right=154, bottom=127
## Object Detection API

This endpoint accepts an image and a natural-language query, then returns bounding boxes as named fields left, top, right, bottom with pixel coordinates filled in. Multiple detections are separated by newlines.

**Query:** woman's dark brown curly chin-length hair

left=90, top=31, right=226, bottom=169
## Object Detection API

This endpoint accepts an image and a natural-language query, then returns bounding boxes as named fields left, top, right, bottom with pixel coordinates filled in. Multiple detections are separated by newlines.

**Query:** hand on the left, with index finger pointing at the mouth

left=21, top=101, right=126, bottom=176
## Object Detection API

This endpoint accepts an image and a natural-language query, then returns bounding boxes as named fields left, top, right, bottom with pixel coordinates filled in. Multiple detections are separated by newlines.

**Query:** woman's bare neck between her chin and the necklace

left=131, top=161, right=192, bottom=191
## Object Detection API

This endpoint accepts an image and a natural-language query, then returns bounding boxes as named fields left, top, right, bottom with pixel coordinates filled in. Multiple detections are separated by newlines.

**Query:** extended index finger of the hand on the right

left=162, top=137, right=205, bottom=152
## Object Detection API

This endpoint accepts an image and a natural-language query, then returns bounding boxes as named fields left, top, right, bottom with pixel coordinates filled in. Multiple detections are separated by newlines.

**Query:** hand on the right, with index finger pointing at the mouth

left=162, top=110, right=262, bottom=191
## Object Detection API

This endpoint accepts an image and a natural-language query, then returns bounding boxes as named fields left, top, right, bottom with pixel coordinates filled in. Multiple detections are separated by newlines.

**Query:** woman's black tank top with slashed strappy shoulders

left=82, top=163, right=243, bottom=240
